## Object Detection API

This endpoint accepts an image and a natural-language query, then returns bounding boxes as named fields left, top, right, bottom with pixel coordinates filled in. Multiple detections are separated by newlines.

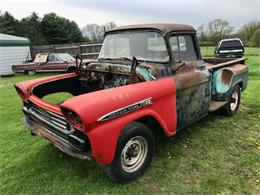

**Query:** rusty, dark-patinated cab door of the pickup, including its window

left=169, top=34, right=211, bottom=130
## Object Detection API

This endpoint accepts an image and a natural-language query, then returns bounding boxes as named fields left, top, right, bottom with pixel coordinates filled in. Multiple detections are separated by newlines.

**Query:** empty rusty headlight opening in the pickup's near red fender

left=61, top=108, right=85, bottom=131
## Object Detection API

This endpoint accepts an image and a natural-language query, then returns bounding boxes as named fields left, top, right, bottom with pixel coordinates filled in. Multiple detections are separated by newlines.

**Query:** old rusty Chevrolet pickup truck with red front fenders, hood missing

left=15, top=24, right=248, bottom=182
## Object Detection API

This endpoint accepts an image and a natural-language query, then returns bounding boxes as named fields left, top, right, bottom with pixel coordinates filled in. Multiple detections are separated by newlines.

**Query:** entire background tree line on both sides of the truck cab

left=0, top=12, right=260, bottom=47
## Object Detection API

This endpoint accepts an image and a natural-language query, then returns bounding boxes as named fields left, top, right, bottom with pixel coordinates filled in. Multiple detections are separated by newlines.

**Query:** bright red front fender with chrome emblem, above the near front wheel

left=62, top=78, right=177, bottom=165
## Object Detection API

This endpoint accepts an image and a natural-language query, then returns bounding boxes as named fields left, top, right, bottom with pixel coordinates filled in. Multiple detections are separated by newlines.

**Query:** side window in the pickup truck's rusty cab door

left=170, top=35, right=198, bottom=62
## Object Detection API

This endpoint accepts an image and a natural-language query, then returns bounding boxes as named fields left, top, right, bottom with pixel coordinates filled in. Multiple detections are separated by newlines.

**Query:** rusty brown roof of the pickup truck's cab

left=108, top=23, right=196, bottom=33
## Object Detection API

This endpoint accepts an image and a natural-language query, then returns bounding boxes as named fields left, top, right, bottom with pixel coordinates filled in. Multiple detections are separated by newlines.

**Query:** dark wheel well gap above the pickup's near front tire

left=136, top=116, right=165, bottom=138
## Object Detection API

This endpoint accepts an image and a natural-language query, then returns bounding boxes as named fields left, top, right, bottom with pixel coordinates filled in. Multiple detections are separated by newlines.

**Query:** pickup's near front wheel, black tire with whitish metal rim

left=105, top=122, right=155, bottom=183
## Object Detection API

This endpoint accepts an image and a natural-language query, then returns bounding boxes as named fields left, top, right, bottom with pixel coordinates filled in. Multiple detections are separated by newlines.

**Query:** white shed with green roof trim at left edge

left=0, top=33, right=31, bottom=76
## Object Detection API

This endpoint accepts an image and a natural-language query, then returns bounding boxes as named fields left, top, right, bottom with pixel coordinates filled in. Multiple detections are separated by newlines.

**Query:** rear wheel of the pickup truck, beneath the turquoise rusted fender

left=220, top=85, right=241, bottom=116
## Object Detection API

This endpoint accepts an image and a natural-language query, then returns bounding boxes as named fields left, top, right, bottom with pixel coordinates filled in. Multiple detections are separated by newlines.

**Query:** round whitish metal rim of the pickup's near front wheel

left=121, top=136, right=148, bottom=173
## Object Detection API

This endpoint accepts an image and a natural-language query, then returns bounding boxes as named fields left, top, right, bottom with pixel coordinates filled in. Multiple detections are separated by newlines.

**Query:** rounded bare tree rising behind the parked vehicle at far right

left=208, top=19, right=234, bottom=44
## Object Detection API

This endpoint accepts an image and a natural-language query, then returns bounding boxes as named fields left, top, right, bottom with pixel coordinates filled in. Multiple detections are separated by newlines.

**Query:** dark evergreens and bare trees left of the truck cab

left=0, top=12, right=116, bottom=45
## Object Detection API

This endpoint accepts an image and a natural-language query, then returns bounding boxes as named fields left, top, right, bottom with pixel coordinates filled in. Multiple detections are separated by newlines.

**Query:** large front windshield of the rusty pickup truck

left=98, top=31, right=169, bottom=62
